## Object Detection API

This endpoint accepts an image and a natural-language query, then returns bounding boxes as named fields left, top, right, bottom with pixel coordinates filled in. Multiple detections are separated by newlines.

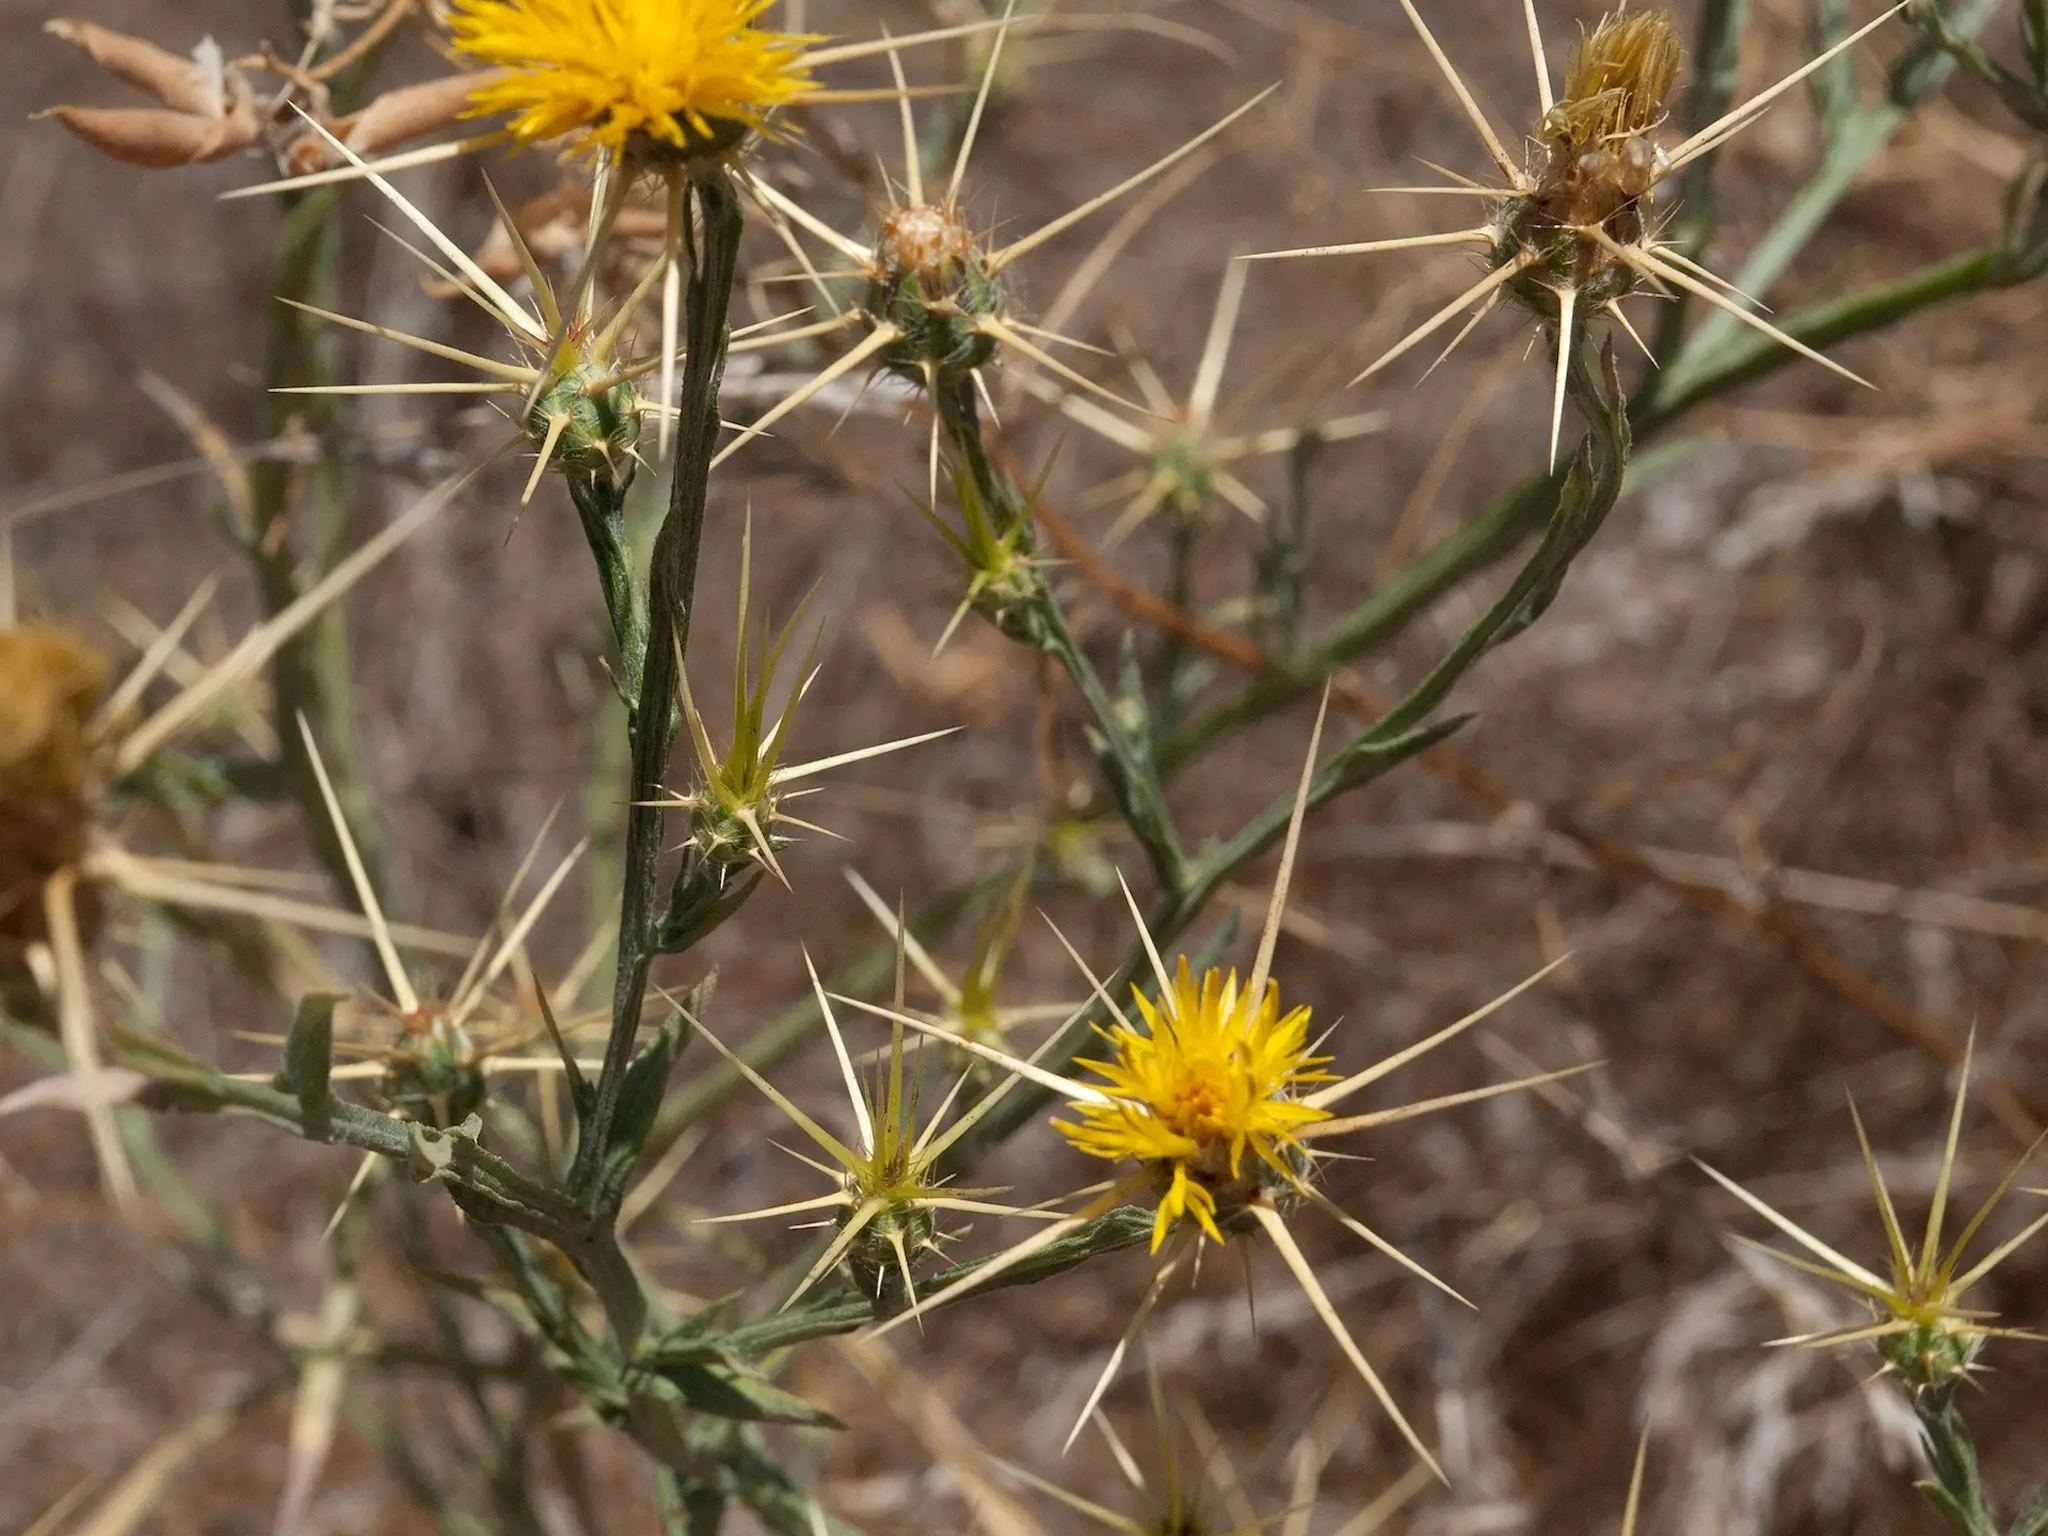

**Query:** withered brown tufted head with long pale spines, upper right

left=1251, top=0, right=1905, bottom=463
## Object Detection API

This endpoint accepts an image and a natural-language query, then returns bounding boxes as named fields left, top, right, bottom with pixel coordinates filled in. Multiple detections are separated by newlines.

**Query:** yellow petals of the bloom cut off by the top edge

left=451, top=0, right=815, bottom=154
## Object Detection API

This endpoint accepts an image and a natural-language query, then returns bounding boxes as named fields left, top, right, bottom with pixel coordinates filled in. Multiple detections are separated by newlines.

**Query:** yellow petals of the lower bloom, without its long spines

left=1053, top=956, right=1329, bottom=1251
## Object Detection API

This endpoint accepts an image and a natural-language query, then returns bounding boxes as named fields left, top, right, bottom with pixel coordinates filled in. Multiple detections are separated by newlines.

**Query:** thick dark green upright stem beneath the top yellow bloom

left=571, top=166, right=743, bottom=1200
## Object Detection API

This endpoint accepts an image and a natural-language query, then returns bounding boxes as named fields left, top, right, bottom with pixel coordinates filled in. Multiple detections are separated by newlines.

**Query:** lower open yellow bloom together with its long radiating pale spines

left=844, top=717, right=1593, bottom=1477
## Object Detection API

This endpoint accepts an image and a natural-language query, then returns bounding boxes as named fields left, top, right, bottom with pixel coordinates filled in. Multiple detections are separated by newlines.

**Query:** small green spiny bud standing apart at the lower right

left=1700, top=1032, right=2048, bottom=1395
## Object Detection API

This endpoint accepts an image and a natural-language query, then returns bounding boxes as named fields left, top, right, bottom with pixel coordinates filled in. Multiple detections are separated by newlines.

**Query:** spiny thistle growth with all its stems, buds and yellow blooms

left=12, top=0, right=2048, bottom=1536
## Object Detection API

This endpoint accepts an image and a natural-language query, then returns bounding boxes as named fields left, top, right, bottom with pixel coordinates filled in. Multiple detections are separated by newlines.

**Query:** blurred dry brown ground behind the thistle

left=0, top=0, right=2048, bottom=1536
